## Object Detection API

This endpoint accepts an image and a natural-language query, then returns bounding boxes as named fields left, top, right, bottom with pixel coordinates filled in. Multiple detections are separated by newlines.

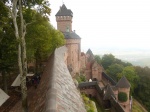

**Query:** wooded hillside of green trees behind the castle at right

left=95, top=54, right=150, bottom=111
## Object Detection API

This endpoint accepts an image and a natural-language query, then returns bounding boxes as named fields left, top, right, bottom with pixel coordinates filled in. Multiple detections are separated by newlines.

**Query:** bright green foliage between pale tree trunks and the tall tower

left=24, top=9, right=65, bottom=63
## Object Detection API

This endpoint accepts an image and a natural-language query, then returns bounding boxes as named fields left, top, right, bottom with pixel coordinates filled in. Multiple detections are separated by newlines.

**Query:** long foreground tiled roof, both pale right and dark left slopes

left=10, top=47, right=86, bottom=112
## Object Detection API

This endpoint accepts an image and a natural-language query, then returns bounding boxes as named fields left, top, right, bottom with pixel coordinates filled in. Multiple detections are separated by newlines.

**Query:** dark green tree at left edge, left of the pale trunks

left=0, top=2, right=17, bottom=93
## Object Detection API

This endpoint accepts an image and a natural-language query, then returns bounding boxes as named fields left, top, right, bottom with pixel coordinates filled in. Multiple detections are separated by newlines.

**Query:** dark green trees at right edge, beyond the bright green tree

left=134, top=66, right=150, bottom=111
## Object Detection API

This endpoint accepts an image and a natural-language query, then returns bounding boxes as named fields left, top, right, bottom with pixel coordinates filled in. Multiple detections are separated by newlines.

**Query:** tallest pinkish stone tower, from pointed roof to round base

left=55, top=4, right=81, bottom=75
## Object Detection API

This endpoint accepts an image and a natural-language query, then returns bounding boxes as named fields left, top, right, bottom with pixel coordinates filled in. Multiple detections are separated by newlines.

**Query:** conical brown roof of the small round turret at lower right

left=116, top=76, right=131, bottom=88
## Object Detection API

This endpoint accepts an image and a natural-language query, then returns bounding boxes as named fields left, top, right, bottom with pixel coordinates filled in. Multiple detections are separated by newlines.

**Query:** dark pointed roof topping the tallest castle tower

left=55, top=4, right=73, bottom=17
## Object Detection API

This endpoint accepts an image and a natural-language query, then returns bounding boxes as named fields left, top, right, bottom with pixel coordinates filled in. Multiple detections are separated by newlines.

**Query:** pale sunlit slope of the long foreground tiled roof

left=46, top=47, right=86, bottom=112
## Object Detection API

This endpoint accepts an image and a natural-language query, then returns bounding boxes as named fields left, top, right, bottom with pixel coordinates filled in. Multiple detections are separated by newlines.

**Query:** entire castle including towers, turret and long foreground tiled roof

left=0, top=4, right=132, bottom=112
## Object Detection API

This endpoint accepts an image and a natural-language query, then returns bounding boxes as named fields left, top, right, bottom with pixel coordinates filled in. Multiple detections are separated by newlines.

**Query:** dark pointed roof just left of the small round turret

left=103, top=84, right=115, bottom=100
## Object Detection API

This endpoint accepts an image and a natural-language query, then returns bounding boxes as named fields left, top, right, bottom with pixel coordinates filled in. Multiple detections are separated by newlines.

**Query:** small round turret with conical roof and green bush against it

left=116, top=76, right=130, bottom=107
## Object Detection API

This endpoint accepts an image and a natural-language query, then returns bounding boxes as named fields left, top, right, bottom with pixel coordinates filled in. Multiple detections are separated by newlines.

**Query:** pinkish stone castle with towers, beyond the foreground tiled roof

left=56, top=4, right=132, bottom=112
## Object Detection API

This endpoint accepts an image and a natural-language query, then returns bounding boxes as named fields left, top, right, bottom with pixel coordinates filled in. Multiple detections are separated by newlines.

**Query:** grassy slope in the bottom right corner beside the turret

left=132, top=99, right=148, bottom=112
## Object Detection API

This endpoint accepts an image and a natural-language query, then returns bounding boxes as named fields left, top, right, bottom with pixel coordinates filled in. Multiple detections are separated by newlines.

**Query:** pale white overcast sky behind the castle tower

left=50, top=0, right=150, bottom=55
